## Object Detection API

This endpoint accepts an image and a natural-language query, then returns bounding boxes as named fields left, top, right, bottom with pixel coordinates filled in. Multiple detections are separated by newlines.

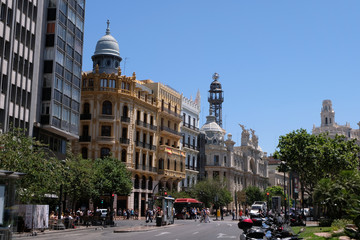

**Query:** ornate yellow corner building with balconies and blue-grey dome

left=74, top=23, right=185, bottom=216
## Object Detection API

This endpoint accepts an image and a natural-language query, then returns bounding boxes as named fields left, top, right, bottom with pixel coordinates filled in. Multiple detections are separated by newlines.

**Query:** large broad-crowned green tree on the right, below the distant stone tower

left=274, top=129, right=359, bottom=196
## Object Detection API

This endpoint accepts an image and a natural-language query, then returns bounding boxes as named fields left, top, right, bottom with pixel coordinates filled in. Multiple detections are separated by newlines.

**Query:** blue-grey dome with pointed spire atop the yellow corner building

left=91, top=20, right=122, bottom=74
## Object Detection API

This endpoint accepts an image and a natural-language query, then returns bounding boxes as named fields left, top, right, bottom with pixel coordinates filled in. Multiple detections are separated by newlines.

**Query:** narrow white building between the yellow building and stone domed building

left=181, top=91, right=200, bottom=189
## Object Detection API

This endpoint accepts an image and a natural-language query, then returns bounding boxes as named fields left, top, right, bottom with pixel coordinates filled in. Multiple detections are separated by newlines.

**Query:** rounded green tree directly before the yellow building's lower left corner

left=93, top=157, right=132, bottom=199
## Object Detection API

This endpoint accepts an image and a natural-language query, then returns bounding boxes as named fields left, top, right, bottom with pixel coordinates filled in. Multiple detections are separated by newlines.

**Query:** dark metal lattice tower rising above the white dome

left=208, top=73, right=224, bottom=127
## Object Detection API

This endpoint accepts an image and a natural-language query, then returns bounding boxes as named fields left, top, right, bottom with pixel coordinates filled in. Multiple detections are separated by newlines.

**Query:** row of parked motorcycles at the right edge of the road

left=238, top=215, right=305, bottom=240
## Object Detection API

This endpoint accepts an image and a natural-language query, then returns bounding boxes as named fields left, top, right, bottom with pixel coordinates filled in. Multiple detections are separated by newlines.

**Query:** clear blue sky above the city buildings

left=83, top=0, right=360, bottom=154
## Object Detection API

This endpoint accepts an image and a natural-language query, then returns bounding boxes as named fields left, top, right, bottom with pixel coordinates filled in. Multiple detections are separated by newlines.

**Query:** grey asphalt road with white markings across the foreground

left=16, top=218, right=241, bottom=240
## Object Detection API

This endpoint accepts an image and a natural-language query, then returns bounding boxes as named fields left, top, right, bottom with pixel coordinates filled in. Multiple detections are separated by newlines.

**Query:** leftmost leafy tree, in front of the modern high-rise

left=0, top=128, right=63, bottom=203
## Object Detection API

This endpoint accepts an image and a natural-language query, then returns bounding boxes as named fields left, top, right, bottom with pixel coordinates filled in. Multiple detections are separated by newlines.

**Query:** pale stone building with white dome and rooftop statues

left=200, top=75, right=268, bottom=208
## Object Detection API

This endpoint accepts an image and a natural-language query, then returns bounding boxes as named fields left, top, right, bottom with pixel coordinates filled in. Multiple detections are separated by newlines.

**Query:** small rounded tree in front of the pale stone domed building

left=192, top=179, right=232, bottom=208
